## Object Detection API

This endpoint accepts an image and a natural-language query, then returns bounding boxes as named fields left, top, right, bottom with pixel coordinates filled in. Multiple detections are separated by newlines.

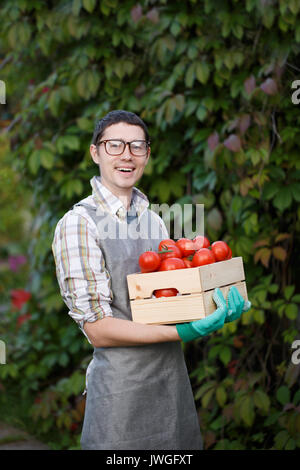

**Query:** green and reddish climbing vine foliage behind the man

left=0, top=0, right=300, bottom=449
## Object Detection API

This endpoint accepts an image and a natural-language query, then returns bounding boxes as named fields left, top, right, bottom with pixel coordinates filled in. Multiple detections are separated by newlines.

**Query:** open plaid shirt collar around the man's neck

left=90, top=176, right=149, bottom=217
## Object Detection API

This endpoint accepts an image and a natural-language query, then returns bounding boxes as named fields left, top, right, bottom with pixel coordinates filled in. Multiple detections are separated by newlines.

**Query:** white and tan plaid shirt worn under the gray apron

left=52, top=176, right=169, bottom=339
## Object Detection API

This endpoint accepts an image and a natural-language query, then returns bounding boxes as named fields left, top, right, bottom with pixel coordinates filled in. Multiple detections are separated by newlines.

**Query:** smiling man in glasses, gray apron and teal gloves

left=52, top=111, right=245, bottom=450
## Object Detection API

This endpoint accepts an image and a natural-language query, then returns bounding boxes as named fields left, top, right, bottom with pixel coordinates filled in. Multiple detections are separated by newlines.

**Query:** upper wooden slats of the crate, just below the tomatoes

left=127, top=257, right=245, bottom=300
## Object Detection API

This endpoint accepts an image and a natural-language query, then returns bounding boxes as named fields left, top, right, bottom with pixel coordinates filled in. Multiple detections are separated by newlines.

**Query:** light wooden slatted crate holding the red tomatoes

left=127, top=257, right=248, bottom=324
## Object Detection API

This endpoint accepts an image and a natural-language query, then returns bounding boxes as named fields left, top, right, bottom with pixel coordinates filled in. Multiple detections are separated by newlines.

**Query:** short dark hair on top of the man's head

left=92, top=109, right=149, bottom=145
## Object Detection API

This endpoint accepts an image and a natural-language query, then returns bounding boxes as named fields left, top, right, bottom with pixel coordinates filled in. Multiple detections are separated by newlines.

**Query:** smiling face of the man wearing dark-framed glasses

left=90, top=122, right=150, bottom=195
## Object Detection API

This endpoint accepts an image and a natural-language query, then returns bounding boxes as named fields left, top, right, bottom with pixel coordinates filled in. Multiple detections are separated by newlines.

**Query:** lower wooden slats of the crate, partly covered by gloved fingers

left=130, top=282, right=248, bottom=325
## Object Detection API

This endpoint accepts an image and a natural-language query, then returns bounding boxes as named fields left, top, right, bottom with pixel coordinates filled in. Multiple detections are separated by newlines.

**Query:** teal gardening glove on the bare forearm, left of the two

left=176, top=287, right=228, bottom=343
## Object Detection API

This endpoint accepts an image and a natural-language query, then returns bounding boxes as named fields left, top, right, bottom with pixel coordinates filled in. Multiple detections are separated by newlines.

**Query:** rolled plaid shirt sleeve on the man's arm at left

left=52, top=211, right=113, bottom=336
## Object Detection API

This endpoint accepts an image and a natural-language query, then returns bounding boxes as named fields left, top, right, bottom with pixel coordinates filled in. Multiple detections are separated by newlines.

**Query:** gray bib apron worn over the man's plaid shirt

left=73, top=203, right=202, bottom=450
